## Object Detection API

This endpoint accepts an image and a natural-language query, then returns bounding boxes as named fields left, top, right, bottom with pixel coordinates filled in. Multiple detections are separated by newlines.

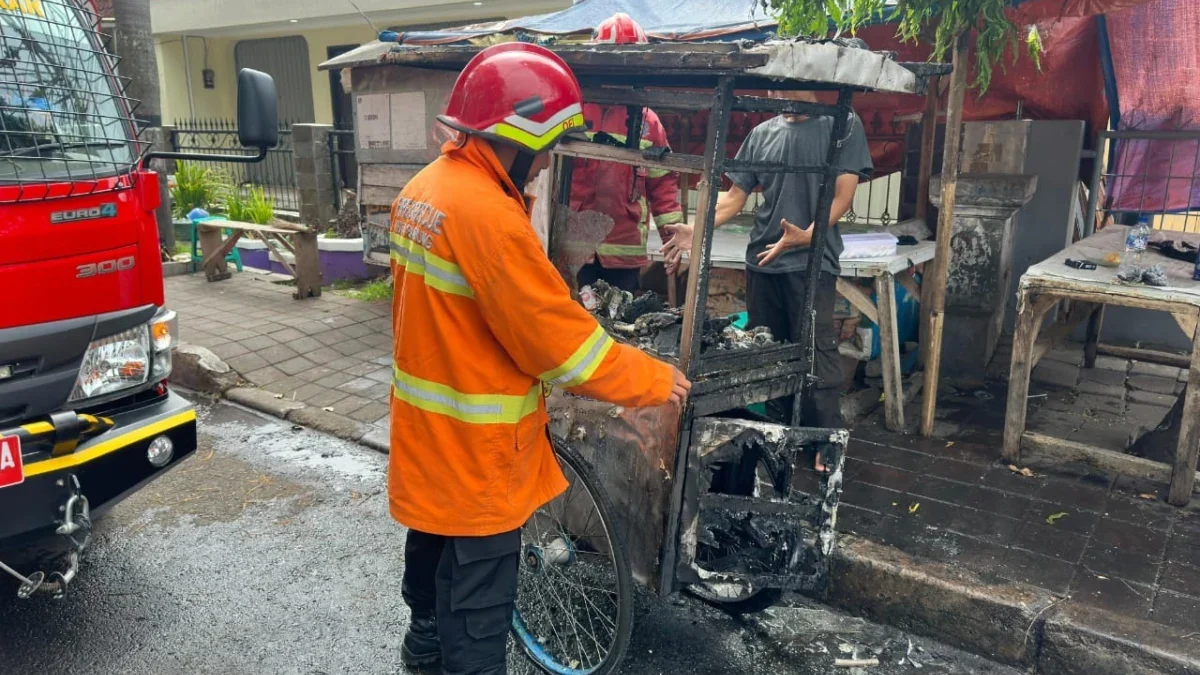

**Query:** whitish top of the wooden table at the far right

left=1020, top=225, right=1200, bottom=306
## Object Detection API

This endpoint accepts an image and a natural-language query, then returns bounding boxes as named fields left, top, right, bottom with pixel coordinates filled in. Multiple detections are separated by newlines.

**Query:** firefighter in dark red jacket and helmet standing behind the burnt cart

left=571, top=12, right=683, bottom=292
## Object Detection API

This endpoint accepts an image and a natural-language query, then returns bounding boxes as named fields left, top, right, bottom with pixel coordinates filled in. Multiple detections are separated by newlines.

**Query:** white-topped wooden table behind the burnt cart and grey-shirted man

left=647, top=228, right=937, bottom=431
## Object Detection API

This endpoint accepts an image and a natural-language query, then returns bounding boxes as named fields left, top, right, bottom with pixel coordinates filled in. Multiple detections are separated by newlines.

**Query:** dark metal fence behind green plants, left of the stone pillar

left=172, top=119, right=300, bottom=211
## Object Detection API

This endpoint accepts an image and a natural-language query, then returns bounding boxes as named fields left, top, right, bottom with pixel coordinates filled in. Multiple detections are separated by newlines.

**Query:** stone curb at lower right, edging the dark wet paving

left=824, top=534, right=1200, bottom=675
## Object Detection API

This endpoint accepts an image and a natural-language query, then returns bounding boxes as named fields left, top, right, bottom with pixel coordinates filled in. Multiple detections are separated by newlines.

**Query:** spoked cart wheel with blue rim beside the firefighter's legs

left=512, top=438, right=634, bottom=675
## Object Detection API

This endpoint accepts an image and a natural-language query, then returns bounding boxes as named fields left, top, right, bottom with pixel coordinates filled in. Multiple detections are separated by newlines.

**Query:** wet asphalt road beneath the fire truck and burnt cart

left=0, top=396, right=1016, bottom=675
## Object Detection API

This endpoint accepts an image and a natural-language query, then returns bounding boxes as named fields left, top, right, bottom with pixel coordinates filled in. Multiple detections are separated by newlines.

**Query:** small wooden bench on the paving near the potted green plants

left=197, top=220, right=322, bottom=300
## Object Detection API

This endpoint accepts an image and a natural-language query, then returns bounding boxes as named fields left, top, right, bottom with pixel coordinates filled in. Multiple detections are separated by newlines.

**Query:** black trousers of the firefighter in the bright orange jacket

left=401, top=530, right=521, bottom=675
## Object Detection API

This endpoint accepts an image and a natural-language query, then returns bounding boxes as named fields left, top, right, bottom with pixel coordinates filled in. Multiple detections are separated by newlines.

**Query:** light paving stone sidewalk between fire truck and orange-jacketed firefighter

left=166, top=273, right=392, bottom=447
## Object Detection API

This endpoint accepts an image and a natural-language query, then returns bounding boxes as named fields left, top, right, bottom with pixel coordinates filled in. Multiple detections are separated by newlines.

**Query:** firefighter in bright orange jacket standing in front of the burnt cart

left=388, top=43, right=690, bottom=675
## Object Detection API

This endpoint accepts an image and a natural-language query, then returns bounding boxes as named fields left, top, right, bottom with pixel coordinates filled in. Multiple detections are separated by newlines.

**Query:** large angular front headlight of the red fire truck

left=68, top=325, right=151, bottom=402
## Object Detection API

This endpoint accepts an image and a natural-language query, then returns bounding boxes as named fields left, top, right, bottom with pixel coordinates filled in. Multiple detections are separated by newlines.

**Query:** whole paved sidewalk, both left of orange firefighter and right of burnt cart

left=166, top=267, right=1200, bottom=661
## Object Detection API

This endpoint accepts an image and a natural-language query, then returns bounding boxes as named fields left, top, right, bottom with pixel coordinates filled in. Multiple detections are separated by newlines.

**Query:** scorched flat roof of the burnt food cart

left=320, top=40, right=948, bottom=94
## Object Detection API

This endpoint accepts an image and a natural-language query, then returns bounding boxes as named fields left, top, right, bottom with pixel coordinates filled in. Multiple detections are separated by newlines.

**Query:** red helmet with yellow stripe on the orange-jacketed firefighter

left=438, top=42, right=586, bottom=154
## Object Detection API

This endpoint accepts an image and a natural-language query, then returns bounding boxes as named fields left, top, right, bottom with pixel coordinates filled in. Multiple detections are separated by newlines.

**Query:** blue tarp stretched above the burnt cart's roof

left=403, top=0, right=776, bottom=44
